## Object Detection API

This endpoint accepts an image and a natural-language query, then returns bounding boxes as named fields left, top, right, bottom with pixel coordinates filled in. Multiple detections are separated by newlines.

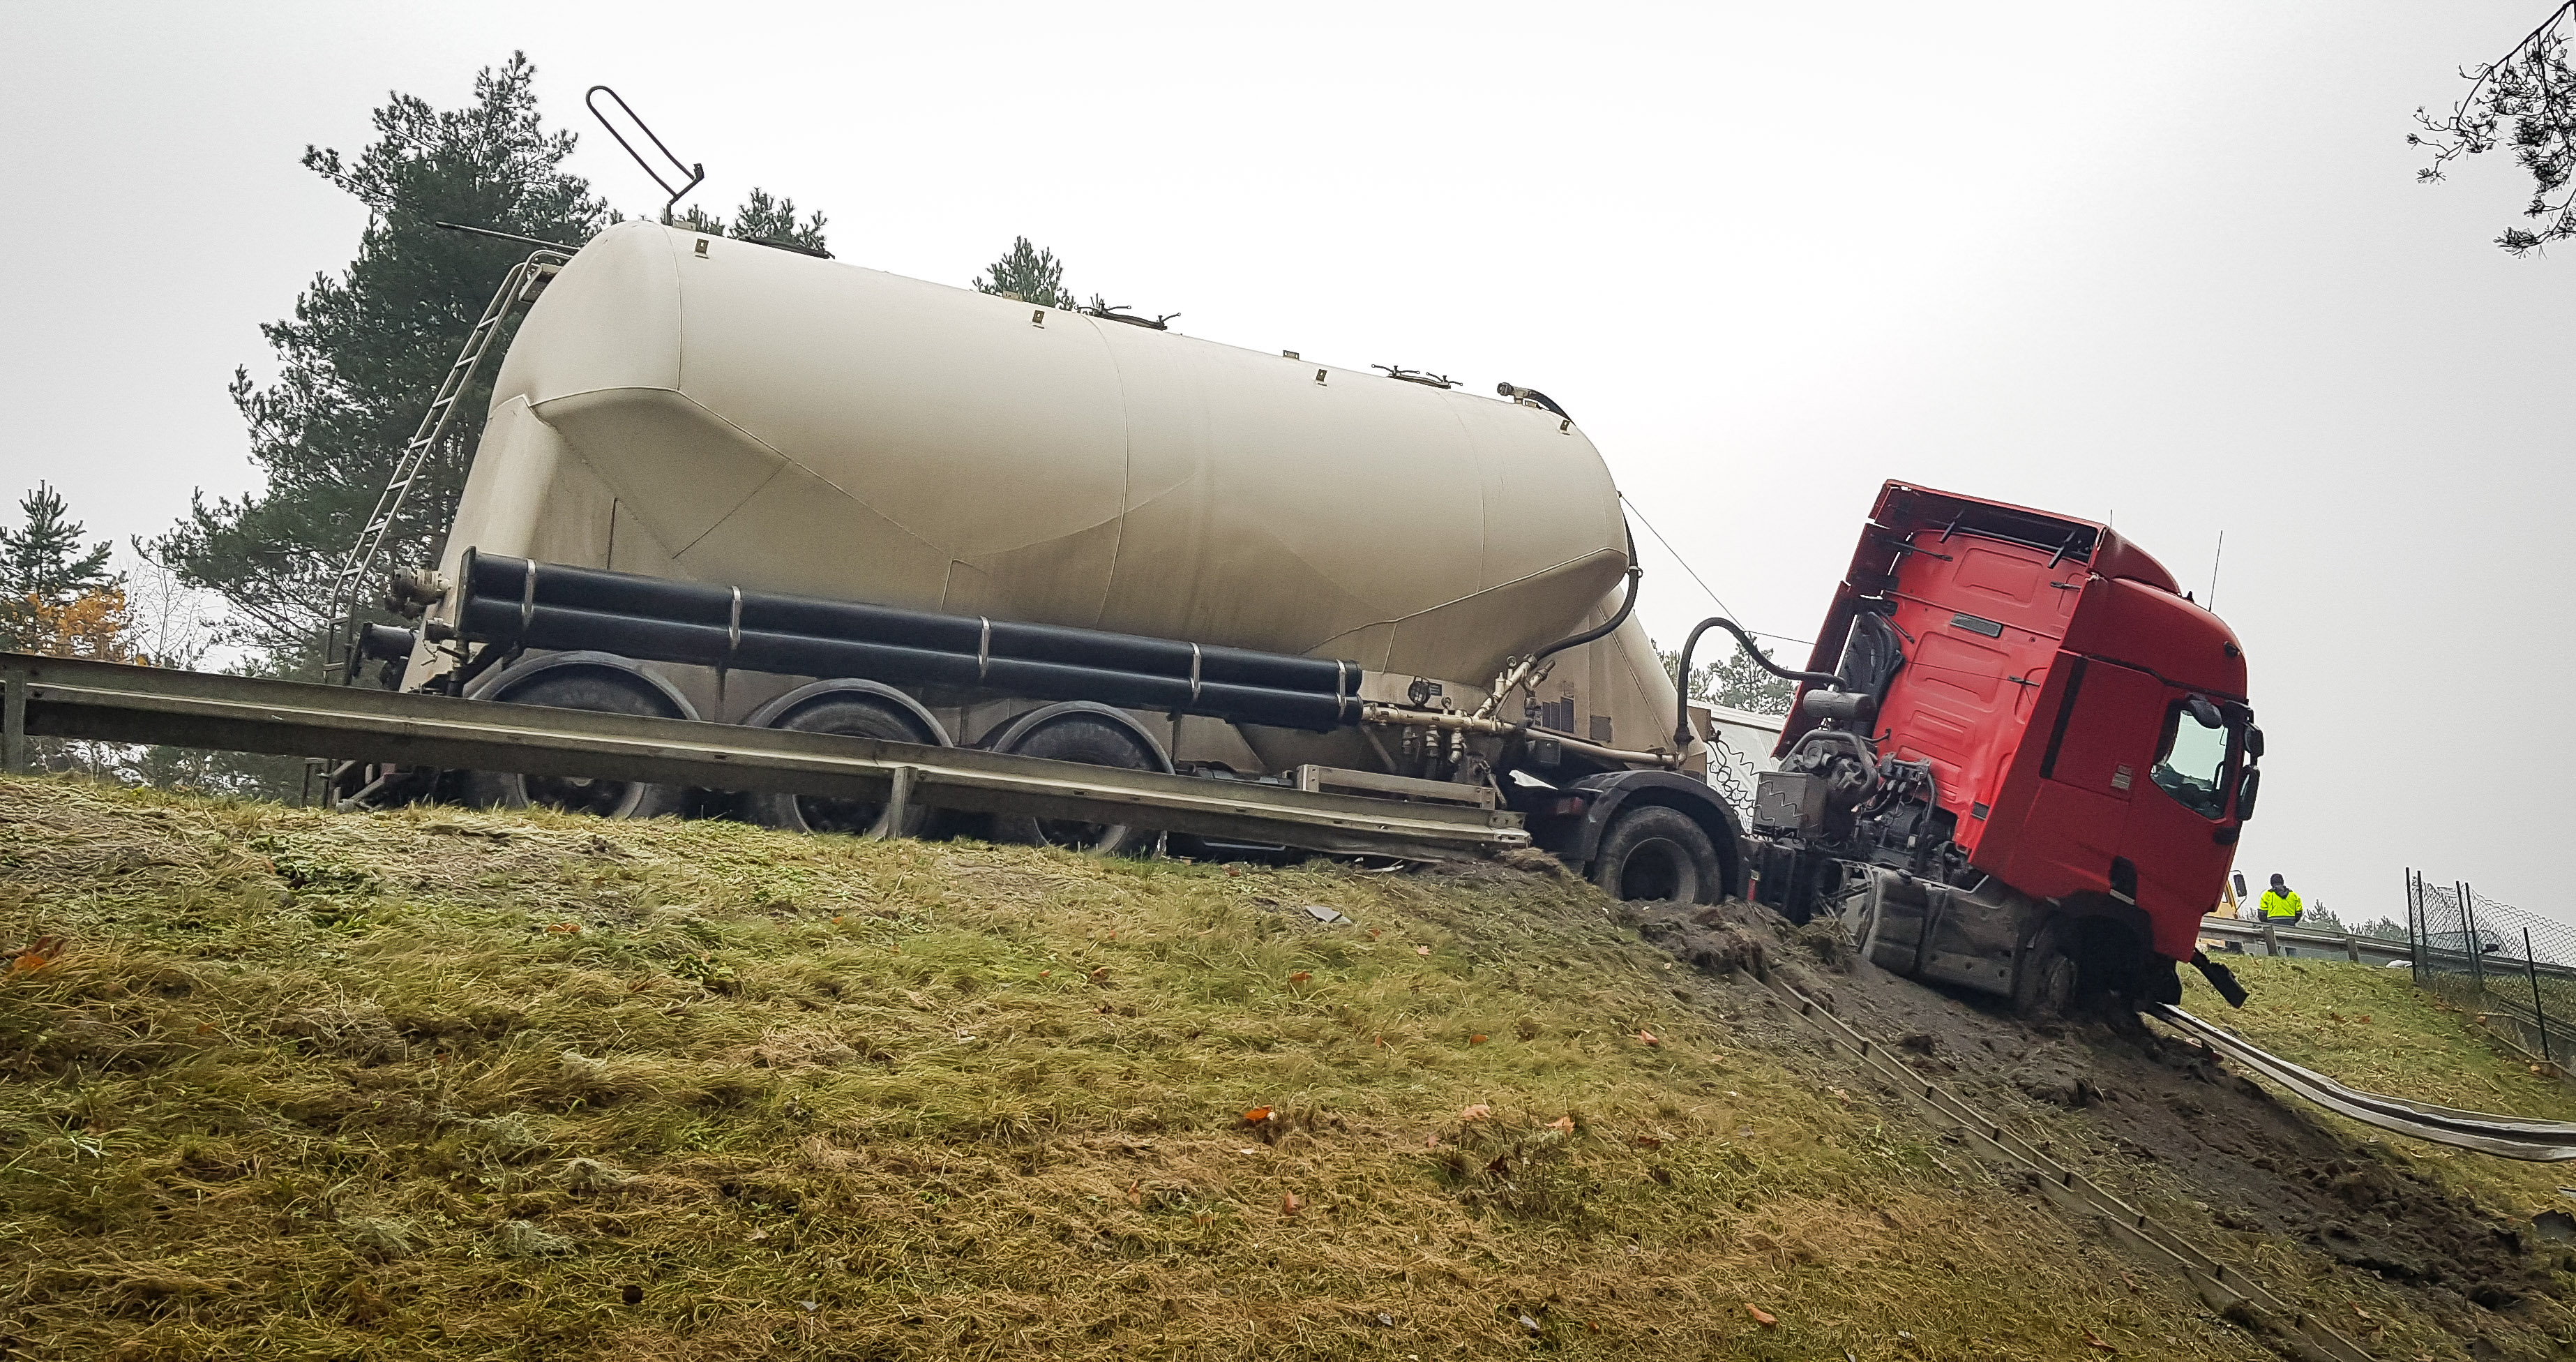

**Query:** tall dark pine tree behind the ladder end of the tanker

left=155, top=54, right=608, bottom=675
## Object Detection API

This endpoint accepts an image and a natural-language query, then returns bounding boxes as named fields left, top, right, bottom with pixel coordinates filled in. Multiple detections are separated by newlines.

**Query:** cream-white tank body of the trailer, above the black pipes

left=443, top=221, right=1627, bottom=689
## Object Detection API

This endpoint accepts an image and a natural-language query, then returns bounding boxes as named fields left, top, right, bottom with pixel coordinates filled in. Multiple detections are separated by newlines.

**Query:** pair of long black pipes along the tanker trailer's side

left=456, top=553, right=1360, bottom=731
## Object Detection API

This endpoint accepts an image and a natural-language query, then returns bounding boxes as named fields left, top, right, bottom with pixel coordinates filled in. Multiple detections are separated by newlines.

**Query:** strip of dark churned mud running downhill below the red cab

left=1636, top=901, right=2561, bottom=1357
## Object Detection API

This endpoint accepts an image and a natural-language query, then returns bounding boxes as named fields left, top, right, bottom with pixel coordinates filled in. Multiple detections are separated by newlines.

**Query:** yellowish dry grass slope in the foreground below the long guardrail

left=0, top=780, right=2261, bottom=1362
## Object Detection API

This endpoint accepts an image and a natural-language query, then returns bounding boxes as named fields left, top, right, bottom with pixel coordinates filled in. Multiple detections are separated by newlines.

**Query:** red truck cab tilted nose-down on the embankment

left=1777, top=481, right=2261, bottom=1004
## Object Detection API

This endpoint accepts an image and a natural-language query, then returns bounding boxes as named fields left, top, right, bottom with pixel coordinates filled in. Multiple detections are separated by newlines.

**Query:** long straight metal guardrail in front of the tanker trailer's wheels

left=0, top=654, right=1530, bottom=860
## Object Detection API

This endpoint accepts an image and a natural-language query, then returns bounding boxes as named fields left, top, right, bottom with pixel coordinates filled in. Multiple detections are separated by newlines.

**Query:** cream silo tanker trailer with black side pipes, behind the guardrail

left=366, top=221, right=1741, bottom=901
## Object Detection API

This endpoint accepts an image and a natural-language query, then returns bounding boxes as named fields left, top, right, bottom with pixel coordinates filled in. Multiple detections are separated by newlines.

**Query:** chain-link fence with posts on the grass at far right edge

left=2406, top=870, right=2576, bottom=1061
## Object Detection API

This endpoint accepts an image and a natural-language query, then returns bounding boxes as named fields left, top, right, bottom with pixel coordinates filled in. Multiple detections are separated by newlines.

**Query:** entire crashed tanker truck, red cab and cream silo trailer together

left=345, top=221, right=2259, bottom=999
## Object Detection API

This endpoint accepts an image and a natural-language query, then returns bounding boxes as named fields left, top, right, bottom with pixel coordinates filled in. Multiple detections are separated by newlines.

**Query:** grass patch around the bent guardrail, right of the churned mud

left=2182, top=955, right=2576, bottom=1223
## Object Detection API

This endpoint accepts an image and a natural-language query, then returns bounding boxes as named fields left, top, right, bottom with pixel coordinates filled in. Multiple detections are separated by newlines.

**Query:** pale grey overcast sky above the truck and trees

left=0, top=0, right=2576, bottom=919
